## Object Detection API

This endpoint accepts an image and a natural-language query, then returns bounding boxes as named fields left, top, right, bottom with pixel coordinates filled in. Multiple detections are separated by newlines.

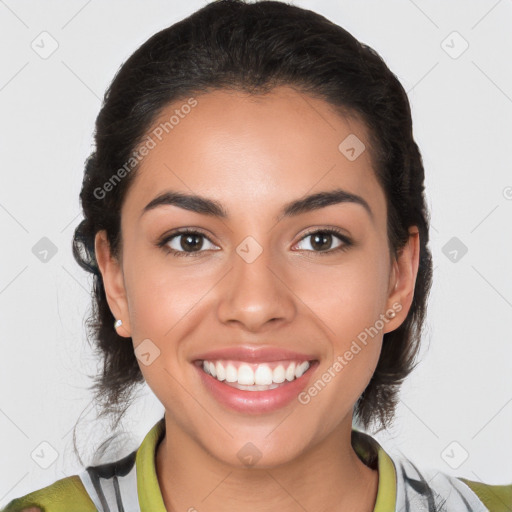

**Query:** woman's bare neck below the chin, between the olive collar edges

left=156, top=415, right=378, bottom=512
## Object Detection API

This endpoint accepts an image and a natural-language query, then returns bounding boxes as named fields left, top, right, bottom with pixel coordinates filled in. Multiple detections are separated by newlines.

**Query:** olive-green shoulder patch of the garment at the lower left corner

left=0, top=475, right=96, bottom=512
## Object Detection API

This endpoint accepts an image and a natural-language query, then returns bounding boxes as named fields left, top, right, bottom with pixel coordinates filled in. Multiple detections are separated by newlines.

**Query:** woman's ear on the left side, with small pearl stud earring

left=94, top=230, right=131, bottom=338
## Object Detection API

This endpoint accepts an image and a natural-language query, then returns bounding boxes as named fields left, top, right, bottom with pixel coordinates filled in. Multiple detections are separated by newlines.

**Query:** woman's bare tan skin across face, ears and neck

left=96, top=87, right=419, bottom=512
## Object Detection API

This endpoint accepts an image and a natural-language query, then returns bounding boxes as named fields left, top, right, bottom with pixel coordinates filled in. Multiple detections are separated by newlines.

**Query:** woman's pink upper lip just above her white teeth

left=193, top=346, right=315, bottom=363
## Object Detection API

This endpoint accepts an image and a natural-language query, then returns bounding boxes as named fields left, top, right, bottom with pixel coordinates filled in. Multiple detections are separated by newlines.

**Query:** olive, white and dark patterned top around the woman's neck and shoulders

left=0, top=418, right=512, bottom=512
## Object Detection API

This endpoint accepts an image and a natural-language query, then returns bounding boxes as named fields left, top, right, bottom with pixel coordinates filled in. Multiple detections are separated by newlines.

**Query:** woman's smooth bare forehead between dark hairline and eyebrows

left=124, top=87, right=385, bottom=222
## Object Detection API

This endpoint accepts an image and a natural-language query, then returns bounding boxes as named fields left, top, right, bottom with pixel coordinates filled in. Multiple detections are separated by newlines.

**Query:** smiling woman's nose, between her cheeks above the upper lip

left=217, top=242, right=297, bottom=332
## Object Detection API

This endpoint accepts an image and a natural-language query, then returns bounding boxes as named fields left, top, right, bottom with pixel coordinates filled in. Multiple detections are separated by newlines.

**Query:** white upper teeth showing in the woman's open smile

left=203, top=361, right=309, bottom=386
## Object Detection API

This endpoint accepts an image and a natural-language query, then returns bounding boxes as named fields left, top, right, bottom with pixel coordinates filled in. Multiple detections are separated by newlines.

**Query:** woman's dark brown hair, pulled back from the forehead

left=73, top=0, right=432, bottom=448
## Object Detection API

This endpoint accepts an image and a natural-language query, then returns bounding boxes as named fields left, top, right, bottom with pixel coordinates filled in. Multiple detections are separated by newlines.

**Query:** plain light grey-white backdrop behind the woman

left=0, top=0, right=512, bottom=504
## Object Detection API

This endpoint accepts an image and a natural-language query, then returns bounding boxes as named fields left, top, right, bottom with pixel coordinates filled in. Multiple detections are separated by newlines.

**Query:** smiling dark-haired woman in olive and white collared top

left=5, top=0, right=512, bottom=512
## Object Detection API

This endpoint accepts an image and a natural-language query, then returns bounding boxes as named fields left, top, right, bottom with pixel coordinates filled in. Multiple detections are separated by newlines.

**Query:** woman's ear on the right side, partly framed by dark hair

left=383, top=226, right=420, bottom=333
